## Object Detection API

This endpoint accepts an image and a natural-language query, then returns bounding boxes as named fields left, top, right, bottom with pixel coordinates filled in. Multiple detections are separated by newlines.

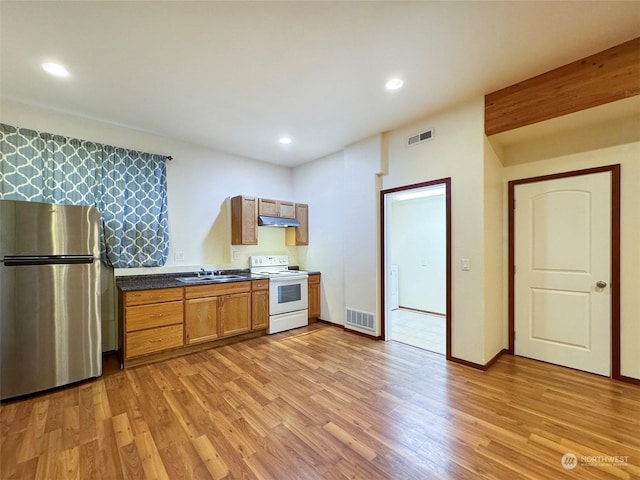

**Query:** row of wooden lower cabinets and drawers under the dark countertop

left=119, top=279, right=269, bottom=365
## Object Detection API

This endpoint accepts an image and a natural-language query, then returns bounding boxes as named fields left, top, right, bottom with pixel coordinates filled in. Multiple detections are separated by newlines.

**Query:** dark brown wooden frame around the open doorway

left=380, top=177, right=453, bottom=360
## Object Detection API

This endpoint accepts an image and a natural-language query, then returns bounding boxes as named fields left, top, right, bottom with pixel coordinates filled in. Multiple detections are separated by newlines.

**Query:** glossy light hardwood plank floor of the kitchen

left=0, top=324, right=640, bottom=480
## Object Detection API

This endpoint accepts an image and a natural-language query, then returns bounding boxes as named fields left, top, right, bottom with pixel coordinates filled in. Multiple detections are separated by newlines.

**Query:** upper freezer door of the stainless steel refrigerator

left=0, top=200, right=100, bottom=260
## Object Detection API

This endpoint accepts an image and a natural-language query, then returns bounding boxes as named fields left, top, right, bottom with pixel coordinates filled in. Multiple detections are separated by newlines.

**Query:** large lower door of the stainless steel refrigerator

left=0, top=260, right=102, bottom=399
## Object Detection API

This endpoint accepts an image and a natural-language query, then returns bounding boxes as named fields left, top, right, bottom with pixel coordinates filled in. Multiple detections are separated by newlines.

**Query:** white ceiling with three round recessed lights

left=0, top=0, right=640, bottom=166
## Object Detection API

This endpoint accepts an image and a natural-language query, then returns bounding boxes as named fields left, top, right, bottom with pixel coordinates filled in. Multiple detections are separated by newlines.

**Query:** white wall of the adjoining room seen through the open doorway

left=387, top=195, right=447, bottom=314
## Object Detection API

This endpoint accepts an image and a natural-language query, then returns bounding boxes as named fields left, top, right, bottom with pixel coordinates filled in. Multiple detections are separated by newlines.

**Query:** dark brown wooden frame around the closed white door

left=507, top=164, right=623, bottom=380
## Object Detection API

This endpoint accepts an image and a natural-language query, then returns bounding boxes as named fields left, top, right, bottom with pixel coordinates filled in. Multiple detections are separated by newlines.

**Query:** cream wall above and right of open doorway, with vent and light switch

left=383, top=97, right=485, bottom=363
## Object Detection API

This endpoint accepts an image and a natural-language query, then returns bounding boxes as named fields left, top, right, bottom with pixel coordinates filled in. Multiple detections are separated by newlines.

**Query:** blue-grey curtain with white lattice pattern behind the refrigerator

left=0, top=123, right=169, bottom=268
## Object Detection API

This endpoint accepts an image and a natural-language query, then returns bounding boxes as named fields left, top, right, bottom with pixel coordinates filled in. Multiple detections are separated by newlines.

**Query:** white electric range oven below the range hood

left=250, top=255, right=309, bottom=334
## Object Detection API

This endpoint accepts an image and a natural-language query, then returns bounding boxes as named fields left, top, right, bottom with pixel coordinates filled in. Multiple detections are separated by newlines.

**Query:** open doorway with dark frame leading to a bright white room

left=381, top=178, right=451, bottom=358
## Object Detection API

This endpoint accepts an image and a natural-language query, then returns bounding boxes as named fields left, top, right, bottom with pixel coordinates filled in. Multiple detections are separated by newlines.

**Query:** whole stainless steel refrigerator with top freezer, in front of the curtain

left=0, top=200, right=102, bottom=400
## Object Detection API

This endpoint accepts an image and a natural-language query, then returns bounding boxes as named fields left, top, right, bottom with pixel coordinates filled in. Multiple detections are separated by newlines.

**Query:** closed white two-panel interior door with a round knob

left=514, top=172, right=611, bottom=376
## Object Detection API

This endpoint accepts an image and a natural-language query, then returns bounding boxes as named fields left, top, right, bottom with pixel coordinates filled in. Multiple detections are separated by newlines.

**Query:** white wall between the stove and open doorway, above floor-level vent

left=293, top=135, right=382, bottom=335
